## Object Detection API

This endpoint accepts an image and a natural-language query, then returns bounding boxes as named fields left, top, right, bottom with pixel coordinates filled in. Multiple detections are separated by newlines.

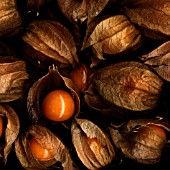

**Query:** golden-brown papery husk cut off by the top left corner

left=0, top=0, right=23, bottom=38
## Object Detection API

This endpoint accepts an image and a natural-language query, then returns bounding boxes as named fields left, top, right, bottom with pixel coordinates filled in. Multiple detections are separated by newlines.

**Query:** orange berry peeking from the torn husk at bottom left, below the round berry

left=30, top=138, right=53, bottom=161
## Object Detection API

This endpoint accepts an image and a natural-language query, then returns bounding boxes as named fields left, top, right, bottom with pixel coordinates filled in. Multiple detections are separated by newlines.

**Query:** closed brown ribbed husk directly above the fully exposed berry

left=22, top=20, right=79, bottom=68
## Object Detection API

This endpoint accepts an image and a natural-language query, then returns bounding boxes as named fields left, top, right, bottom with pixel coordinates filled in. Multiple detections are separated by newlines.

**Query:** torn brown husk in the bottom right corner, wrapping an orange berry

left=109, top=119, right=170, bottom=164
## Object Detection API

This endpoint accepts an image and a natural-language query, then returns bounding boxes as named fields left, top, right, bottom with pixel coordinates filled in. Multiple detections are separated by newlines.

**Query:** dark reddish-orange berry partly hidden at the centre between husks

left=69, top=64, right=91, bottom=92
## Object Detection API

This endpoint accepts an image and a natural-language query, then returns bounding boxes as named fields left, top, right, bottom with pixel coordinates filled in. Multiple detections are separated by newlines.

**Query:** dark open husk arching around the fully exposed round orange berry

left=27, top=68, right=80, bottom=123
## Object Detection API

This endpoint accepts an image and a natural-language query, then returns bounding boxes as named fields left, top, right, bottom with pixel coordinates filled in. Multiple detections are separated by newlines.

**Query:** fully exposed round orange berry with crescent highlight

left=42, top=90, right=75, bottom=121
